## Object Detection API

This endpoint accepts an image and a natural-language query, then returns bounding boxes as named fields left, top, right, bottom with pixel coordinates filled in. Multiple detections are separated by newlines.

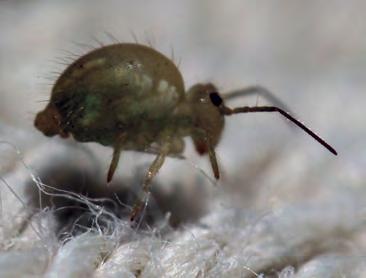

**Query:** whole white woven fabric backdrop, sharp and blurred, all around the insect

left=0, top=0, right=366, bottom=278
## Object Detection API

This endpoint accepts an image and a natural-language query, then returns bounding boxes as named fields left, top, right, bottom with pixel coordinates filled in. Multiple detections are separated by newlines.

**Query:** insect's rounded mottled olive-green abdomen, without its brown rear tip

left=43, top=44, right=190, bottom=150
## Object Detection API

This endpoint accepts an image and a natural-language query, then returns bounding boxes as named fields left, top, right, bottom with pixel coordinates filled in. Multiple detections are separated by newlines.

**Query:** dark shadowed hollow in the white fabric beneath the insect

left=25, top=155, right=205, bottom=240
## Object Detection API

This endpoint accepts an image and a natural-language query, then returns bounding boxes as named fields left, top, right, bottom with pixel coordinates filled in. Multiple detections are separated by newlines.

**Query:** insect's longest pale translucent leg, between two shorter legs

left=130, top=143, right=171, bottom=221
